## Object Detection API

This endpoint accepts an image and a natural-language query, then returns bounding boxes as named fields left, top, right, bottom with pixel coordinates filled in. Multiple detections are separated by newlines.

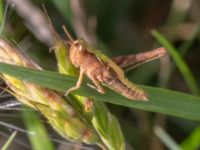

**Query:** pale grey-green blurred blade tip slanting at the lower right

left=154, top=127, right=181, bottom=150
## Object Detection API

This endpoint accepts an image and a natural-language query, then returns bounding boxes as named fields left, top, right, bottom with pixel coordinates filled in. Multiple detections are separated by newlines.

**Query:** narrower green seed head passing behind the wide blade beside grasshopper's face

left=54, top=38, right=125, bottom=150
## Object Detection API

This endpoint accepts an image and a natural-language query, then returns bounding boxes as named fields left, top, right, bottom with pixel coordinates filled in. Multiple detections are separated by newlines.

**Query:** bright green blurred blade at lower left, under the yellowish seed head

left=22, top=108, right=54, bottom=150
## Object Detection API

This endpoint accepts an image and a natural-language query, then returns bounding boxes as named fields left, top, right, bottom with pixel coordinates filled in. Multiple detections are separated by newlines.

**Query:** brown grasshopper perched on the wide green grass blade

left=64, top=28, right=166, bottom=101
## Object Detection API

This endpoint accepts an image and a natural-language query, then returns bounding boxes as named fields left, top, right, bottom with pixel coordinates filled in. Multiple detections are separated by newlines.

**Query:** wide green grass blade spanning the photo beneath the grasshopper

left=0, top=63, right=200, bottom=120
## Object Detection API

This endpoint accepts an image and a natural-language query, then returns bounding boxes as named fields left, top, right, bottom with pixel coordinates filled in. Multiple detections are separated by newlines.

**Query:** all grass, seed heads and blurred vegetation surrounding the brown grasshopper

left=0, top=0, right=200, bottom=150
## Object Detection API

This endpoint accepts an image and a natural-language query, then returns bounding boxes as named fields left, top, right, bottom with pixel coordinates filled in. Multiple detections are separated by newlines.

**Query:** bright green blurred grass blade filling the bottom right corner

left=181, top=127, right=200, bottom=150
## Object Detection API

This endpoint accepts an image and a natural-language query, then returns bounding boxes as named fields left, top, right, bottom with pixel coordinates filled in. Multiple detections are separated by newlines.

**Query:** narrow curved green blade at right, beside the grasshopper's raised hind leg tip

left=152, top=30, right=199, bottom=94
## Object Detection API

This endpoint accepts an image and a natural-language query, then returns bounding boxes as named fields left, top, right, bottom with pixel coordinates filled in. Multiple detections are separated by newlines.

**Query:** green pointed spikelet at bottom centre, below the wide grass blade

left=92, top=102, right=125, bottom=150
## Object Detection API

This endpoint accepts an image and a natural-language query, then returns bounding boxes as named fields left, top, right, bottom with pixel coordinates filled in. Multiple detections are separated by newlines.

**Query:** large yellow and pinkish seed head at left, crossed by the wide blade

left=0, top=38, right=101, bottom=144
